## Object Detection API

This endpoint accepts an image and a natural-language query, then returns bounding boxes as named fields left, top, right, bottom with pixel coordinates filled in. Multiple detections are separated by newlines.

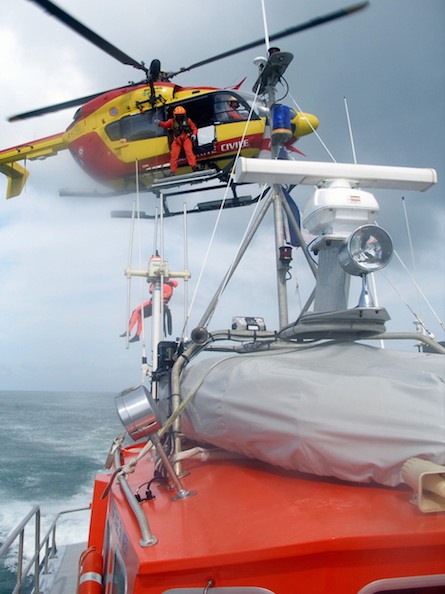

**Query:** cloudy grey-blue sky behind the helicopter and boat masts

left=0, top=0, right=445, bottom=393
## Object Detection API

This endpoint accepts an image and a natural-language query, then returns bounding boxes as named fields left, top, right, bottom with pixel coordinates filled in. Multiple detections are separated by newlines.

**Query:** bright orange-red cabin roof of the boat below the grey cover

left=90, top=447, right=445, bottom=594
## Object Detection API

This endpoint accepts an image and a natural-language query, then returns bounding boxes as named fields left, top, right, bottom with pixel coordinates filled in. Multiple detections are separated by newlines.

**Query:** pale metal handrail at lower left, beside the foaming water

left=0, top=505, right=90, bottom=594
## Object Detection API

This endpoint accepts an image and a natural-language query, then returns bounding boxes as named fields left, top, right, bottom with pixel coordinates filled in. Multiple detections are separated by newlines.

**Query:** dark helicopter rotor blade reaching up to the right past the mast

left=169, top=1, right=369, bottom=78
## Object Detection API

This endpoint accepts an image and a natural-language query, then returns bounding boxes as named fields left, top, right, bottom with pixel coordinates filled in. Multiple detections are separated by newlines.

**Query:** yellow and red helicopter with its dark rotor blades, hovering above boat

left=0, top=0, right=368, bottom=198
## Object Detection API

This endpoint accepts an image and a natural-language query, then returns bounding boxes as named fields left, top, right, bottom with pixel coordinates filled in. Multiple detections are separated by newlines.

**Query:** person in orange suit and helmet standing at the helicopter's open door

left=154, top=105, right=198, bottom=174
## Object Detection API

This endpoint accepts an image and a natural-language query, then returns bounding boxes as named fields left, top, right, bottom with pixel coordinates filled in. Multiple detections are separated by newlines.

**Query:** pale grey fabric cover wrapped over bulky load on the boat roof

left=181, top=343, right=445, bottom=485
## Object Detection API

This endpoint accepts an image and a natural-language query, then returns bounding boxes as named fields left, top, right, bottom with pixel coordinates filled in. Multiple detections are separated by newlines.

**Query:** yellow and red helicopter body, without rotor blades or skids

left=0, top=81, right=318, bottom=197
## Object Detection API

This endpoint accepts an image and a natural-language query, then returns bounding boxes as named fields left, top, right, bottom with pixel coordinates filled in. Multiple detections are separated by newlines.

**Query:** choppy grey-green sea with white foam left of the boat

left=0, top=391, right=124, bottom=594
